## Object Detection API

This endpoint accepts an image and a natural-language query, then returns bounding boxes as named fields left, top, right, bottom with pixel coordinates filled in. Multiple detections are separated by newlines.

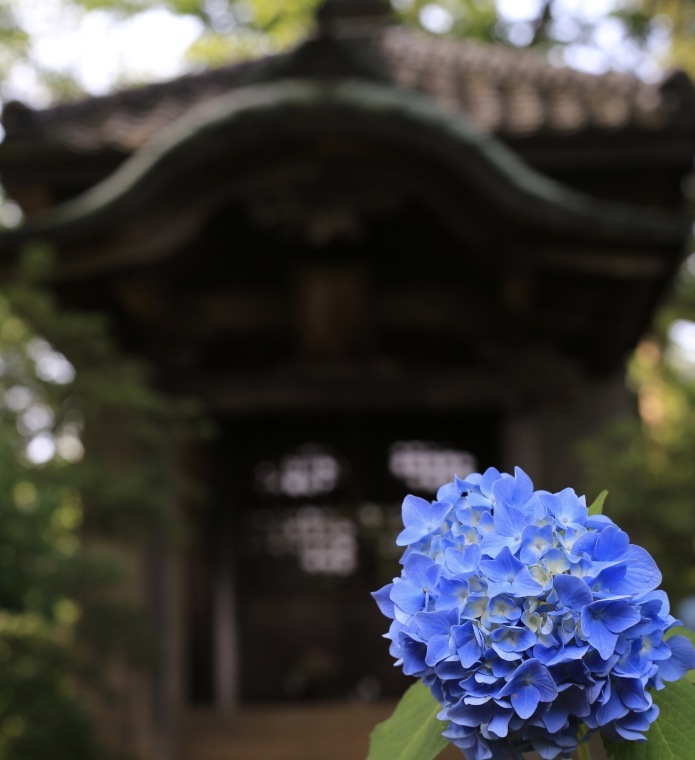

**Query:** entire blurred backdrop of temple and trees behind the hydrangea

left=0, top=0, right=695, bottom=760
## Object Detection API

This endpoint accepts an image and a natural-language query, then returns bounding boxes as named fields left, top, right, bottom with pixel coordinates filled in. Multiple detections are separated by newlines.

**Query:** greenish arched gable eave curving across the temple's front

left=0, top=80, right=688, bottom=276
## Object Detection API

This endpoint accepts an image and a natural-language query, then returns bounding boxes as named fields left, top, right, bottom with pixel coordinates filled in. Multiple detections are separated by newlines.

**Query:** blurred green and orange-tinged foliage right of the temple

left=581, top=265, right=695, bottom=604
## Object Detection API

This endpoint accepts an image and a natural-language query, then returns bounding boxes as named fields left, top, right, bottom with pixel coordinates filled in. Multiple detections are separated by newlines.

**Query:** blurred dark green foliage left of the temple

left=0, top=251, right=196, bottom=760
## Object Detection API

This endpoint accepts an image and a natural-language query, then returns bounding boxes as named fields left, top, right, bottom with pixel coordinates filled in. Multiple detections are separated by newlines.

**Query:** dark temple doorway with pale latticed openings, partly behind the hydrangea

left=188, top=412, right=500, bottom=704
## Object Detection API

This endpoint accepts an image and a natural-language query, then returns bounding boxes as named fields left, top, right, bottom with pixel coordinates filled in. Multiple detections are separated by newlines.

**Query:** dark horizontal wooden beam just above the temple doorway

left=167, top=358, right=582, bottom=414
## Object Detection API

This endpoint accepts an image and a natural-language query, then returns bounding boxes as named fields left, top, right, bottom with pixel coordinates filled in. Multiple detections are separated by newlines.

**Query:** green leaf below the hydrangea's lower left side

left=367, top=681, right=449, bottom=760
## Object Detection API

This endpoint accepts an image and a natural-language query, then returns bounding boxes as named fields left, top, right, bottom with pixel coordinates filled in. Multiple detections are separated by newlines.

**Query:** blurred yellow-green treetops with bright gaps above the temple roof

left=6, top=0, right=695, bottom=98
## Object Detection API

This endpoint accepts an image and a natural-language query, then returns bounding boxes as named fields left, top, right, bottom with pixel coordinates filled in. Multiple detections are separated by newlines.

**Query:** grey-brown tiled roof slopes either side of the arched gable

left=3, top=27, right=695, bottom=151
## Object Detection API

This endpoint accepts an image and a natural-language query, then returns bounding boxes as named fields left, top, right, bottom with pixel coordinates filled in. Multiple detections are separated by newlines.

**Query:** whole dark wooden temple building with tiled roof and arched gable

left=0, top=0, right=695, bottom=760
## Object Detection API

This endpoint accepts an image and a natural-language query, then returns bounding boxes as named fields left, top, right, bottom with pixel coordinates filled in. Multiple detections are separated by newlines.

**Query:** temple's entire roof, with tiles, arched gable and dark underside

left=0, top=5, right=695, bottom=382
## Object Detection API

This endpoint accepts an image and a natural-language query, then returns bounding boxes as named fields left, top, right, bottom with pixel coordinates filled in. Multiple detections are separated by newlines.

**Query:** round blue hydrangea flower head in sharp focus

left=373, top=468, right=695, bottom=760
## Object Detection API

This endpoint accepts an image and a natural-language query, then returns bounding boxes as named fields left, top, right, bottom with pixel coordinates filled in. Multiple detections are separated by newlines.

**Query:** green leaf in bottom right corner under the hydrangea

left=604, top=671, right=695, bottom=760
